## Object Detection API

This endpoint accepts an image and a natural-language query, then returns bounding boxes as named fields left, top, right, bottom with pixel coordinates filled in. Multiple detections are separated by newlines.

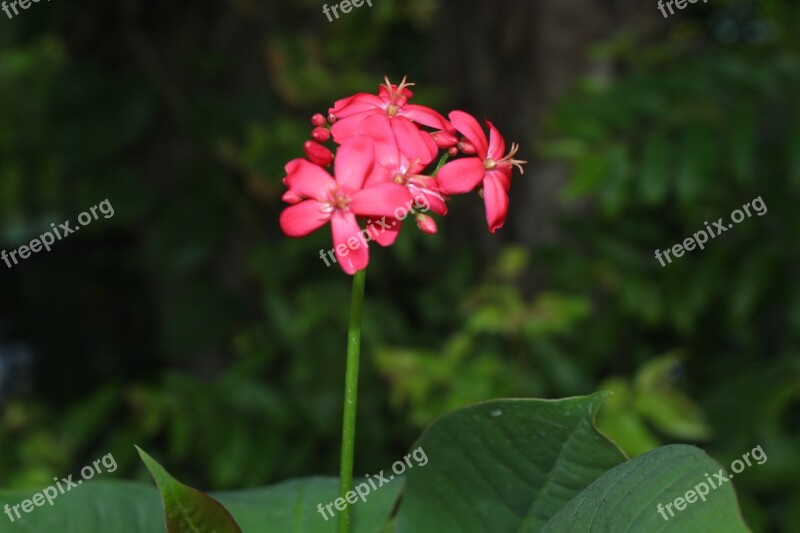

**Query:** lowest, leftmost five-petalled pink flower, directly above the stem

left=280, top=137, right=410, bottom=275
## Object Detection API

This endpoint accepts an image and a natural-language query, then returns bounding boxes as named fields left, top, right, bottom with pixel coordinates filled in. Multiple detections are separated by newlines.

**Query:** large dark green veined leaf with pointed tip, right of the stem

left=397, top=393, right=625, bottom=533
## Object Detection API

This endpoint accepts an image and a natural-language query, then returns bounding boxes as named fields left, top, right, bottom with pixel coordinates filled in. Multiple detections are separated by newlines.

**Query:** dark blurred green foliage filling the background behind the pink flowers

left=0, top=0, right=800, bottom=531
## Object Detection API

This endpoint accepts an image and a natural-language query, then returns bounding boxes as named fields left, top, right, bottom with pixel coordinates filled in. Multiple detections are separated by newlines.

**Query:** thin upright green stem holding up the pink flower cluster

left=339, top=270, right=367, bottom=533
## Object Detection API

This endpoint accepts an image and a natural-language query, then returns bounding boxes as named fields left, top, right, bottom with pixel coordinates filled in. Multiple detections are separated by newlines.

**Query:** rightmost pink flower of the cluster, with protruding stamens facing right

left=436, top=111, right=527, bottom=233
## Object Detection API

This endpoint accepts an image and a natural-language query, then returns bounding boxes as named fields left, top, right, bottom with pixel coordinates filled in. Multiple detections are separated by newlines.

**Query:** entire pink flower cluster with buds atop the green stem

left=280, top=78, right=525, bottom=275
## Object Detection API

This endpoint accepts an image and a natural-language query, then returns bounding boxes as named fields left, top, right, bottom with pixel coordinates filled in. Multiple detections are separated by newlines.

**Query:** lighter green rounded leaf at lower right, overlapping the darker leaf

left=540, top=445, right=749, bottom=533
